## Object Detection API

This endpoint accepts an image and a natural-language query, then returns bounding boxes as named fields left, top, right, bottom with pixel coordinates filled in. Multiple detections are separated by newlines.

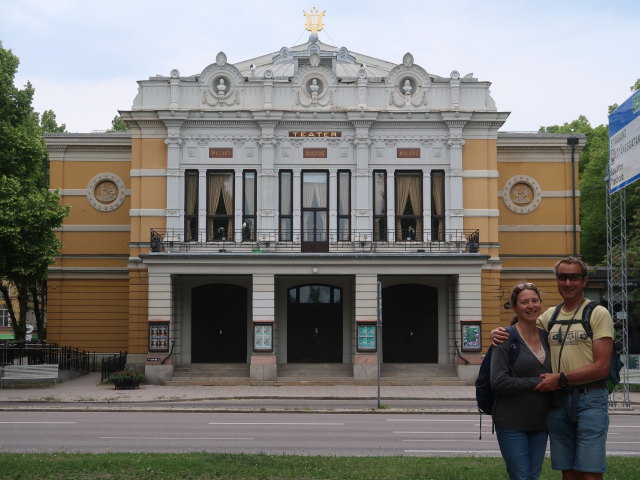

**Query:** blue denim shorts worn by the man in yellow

left=547, top=388, right=609, bottom=473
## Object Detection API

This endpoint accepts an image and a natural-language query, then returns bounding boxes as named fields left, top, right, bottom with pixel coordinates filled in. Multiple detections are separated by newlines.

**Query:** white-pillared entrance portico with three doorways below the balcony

left=143, top=253, right=484, bottom=381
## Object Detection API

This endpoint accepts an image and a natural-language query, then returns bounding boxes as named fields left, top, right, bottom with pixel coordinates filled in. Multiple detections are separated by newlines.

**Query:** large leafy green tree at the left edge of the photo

left=0, top=42, right=69, bottom=340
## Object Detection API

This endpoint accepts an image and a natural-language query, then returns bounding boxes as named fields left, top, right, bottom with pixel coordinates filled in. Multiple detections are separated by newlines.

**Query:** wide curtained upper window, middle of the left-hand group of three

left=207, top=170, right=233, bottom=241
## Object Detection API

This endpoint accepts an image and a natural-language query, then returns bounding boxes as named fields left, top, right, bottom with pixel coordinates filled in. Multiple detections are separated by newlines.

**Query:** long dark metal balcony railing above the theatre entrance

left=150, top=229, right=480, bottom=253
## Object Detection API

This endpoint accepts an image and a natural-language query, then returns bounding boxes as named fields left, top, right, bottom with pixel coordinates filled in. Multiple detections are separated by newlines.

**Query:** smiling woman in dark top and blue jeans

left=491, top=283, right=551, bottom=480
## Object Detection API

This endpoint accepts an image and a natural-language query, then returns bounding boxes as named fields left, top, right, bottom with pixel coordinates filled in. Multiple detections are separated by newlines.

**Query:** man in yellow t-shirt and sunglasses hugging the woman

left=491, top=257, right=613, bottom=480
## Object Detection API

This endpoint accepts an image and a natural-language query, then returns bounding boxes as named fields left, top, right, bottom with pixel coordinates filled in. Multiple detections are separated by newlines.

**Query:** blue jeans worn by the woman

left=496, top=427, right=547, bottom=480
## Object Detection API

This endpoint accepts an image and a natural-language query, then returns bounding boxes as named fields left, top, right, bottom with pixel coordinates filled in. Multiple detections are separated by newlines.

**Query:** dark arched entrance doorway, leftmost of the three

left=191, top=284, right=247, bottom=363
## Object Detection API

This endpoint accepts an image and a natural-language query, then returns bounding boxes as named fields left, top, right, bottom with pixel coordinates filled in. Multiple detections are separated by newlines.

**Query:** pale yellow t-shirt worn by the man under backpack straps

left=538, top=300, right=613, bottom=373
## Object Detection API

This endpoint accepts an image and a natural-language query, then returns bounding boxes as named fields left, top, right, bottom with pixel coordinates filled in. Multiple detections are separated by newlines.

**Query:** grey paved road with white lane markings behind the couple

left=0, top=410, right=640, bottom=456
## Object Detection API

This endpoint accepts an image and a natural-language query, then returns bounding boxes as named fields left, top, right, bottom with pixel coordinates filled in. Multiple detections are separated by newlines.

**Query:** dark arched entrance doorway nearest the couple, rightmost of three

left=382, top=284, right=438, bottom=363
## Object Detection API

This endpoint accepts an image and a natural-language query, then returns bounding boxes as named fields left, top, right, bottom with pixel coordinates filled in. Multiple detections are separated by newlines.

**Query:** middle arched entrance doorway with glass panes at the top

left=287, top=285, right=342, bottom=363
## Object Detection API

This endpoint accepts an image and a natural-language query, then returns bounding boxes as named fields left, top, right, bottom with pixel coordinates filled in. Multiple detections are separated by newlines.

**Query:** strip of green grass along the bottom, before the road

left=0, top=453, right=640, bottom=480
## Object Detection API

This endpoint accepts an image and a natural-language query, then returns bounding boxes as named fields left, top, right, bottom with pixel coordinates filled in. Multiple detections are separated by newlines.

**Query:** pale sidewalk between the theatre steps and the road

left=0, top=373, right=640, bottom=413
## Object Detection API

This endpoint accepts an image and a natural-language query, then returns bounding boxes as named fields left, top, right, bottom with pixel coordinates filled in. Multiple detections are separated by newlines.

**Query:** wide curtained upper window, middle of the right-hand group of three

left=396, top=172, right=422, bottom=240
